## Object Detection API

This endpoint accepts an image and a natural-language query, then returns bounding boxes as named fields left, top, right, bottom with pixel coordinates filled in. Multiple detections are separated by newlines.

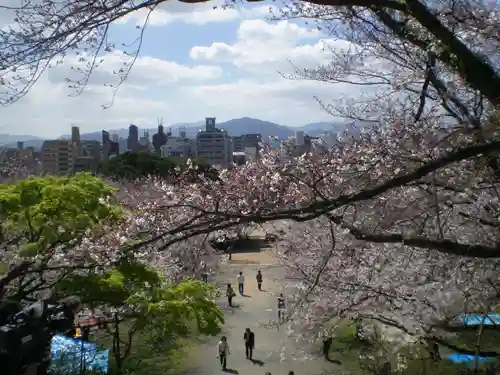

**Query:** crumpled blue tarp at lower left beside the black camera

left=51, top=335, right=109, bottom=374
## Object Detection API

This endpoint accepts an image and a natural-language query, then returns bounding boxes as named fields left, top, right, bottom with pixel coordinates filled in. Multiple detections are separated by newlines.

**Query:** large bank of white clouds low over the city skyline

left=0, top=13, right=368, bottom=137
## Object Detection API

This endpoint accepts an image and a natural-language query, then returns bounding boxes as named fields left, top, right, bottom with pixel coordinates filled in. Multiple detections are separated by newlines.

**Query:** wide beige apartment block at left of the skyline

left=42, top=140, right=77, bottom=175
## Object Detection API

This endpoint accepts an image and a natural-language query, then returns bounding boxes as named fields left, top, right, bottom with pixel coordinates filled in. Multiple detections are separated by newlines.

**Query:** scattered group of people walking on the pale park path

left=217, top=270, right=294, bottom=375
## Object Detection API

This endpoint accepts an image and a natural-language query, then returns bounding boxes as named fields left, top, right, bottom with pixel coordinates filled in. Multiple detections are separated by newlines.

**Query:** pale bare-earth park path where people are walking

left=189, top=252, right=338, bottom=375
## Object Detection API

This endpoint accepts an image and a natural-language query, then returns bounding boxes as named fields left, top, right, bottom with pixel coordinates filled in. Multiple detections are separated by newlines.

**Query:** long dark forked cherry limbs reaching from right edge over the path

left=142, top=141, right=500, bottom=257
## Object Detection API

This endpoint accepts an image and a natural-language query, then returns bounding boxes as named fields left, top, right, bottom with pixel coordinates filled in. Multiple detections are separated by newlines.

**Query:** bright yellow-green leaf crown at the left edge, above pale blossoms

left=0, top=173, right=121, bottom=256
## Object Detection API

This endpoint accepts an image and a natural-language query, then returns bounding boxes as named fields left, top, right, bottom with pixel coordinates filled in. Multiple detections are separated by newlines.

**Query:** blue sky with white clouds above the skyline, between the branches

left=0, top=0, right=360, bottom=137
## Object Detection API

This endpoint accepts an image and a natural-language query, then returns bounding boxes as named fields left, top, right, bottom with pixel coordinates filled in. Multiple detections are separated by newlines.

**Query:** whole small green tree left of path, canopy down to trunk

left=54, top=256, right=224, bottom=374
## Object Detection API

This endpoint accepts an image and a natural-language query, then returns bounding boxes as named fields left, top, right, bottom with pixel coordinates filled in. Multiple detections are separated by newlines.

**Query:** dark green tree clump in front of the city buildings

left=99, top=152, right=216, bottom=180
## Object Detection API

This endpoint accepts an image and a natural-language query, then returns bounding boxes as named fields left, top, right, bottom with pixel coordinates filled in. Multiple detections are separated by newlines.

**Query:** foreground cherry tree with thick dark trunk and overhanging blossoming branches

left=1, top=0, right=500, bottom=264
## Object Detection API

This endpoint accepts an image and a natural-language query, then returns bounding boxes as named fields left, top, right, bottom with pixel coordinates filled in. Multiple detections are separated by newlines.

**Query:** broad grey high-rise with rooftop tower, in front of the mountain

left=196, top=117, right=233, bottom=165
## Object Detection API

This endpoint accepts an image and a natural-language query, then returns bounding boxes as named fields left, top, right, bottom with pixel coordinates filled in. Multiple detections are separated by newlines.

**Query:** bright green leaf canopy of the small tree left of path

left=57, top=257, right=224, bottom=362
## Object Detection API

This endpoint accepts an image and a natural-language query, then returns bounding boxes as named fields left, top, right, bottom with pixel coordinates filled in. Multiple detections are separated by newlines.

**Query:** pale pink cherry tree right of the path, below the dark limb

left=276, top=217, right=500, bottom=355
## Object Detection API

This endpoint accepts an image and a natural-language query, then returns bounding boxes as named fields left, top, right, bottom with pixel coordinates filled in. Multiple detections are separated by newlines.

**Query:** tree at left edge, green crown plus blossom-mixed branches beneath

left=0, top=173, right=122, bottom=300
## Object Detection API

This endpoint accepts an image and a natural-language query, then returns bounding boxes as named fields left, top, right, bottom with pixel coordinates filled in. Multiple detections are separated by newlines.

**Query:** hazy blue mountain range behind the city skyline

left=0, top=117, right=360, bottom=149
